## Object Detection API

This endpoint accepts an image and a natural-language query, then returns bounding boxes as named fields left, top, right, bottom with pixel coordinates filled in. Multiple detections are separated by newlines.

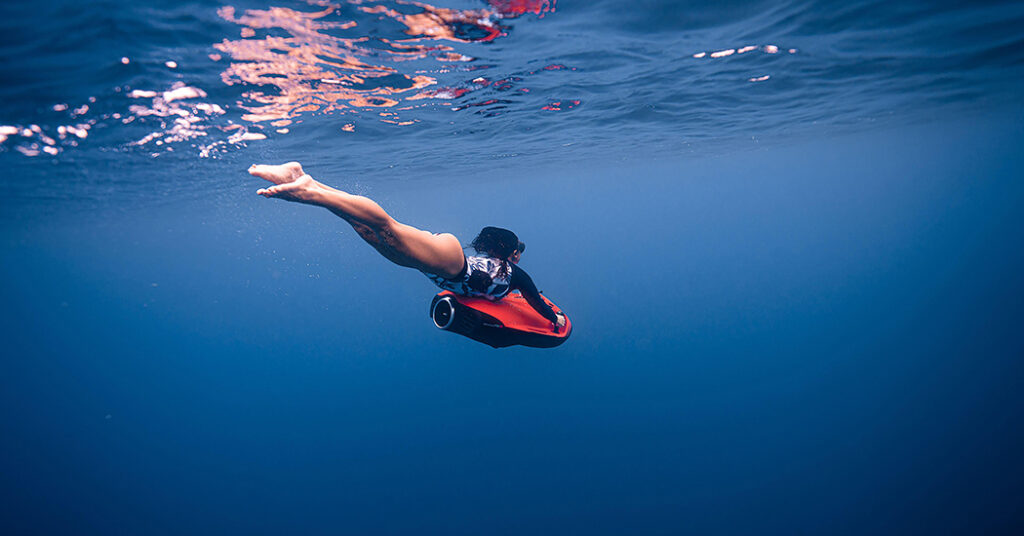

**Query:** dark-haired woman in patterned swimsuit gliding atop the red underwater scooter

left=249, top=162, right=565, bottom=332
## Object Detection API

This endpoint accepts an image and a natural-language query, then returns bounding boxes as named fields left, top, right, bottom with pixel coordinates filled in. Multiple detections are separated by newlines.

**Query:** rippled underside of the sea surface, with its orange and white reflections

left=0, top=0, right=1024, bottom=196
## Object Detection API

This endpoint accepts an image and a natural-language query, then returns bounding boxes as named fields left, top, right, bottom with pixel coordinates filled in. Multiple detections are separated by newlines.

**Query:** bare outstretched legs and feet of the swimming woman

left=249, top=162, right=464, bottom=279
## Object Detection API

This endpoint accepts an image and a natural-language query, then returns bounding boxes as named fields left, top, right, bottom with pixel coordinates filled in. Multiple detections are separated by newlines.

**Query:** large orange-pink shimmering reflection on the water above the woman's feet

left=214, top=0, right=553, bottom=127
